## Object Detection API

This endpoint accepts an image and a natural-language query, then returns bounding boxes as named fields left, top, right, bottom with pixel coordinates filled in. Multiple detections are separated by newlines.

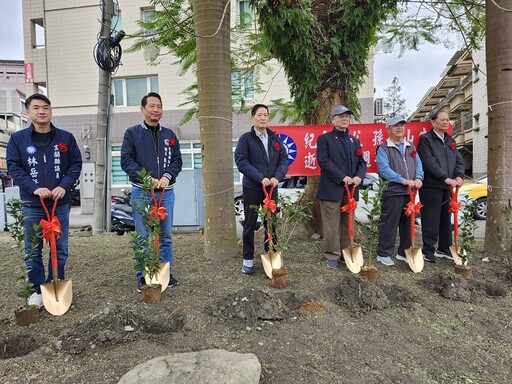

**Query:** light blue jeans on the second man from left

left=130, top=186, right=174, bottom=278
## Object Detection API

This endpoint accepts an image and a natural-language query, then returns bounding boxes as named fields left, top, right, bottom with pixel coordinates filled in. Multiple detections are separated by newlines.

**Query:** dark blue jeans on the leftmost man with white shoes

left=23, top=204, right=71, bottom=293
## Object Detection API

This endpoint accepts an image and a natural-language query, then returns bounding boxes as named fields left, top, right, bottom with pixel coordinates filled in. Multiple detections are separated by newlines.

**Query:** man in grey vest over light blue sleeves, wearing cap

left=376, top=116, right=423, bottom=265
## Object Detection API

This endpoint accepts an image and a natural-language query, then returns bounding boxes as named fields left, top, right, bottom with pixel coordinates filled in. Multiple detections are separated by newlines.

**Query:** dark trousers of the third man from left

left=242, top=187, right=278, bottom=260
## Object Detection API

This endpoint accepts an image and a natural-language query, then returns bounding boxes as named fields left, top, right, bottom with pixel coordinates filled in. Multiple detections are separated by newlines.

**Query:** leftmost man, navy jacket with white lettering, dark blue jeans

left=7, top=94, right=82, bottom=308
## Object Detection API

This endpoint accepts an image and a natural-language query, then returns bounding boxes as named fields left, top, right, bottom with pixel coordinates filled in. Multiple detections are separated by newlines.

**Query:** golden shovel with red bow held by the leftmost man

left=39, top=197, right=73, bottom=316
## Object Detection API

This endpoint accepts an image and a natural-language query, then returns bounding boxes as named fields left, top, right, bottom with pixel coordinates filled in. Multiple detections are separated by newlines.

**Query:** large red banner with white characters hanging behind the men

left=270, top=121, right=451, bottom=176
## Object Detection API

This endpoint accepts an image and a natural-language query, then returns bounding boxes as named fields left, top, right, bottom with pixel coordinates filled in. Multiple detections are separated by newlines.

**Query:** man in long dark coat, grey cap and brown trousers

left=316, top=105, right=366, bottom=268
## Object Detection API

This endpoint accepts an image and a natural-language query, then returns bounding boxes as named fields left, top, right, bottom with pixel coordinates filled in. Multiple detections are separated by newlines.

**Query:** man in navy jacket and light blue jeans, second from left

left=121, top=92, right=183, bottom=293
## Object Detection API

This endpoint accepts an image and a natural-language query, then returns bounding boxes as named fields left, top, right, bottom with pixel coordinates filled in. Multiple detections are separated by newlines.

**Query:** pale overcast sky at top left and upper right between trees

left=0, top=0, right=455, bottom=113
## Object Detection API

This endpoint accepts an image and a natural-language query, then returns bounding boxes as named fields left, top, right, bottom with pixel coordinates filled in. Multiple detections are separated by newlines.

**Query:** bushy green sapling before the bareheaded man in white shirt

left=251, top=194, right=313, bottom=252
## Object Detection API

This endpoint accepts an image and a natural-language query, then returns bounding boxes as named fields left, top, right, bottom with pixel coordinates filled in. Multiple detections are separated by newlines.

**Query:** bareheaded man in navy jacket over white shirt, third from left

left=235, top=104, right=288, bottom=275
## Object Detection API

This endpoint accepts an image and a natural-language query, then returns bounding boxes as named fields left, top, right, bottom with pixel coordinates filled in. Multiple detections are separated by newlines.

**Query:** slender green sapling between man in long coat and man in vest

left=358, top=179, right=388, bottom=267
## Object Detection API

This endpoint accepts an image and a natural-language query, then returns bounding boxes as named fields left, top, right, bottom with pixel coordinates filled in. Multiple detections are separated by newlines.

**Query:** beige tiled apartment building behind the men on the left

left=23, top=0, right=374, bottom=209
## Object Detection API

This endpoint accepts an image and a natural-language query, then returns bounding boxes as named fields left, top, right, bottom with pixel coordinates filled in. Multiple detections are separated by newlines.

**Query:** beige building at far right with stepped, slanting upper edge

left=410, top=48, right=488, bottom=178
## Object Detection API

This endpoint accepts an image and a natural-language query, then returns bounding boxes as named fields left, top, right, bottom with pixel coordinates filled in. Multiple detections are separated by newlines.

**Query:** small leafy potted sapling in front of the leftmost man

left=6, top=199, right=41, bottom=306
